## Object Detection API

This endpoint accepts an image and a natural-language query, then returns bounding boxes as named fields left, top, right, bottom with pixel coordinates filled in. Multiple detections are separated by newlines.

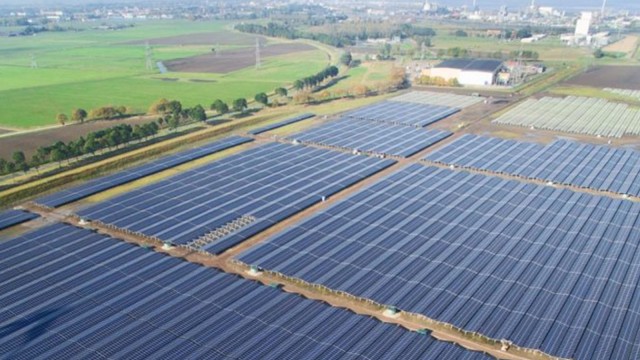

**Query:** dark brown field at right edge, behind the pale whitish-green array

left=564, top=66, right=640, bottom=90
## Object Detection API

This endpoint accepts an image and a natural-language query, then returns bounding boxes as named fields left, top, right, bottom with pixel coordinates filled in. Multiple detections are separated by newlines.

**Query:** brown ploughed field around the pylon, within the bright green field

left=164, top=44, right=315, bottom=74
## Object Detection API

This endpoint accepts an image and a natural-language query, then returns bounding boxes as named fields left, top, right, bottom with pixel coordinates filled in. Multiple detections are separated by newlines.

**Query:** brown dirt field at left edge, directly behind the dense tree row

left=0, top=117, right=162, bottom=159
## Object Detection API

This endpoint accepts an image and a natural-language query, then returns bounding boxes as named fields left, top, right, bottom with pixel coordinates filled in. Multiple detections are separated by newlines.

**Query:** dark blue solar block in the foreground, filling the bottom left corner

left=0, top=224, right=489, bottom=360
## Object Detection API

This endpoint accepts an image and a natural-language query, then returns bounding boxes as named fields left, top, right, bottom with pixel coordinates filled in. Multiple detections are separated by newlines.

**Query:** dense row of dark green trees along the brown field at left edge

left=0, top=121, right=162, bottom=175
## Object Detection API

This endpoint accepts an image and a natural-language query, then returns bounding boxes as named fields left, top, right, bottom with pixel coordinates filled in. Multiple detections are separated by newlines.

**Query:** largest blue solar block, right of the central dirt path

left=239, top=164, right=640, bottom=359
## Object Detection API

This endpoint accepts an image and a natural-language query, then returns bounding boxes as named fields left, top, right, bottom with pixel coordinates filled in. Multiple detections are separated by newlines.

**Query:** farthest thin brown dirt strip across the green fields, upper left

left=124, top=32, right=267, bottom=46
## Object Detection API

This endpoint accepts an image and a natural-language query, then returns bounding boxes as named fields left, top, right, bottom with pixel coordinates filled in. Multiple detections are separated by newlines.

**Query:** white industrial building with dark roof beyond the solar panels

left=423, top=59, right=505, bottom=86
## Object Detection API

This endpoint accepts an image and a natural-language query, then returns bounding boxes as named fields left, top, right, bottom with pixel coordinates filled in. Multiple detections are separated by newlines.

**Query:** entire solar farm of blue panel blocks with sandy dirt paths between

left=6, top=91, right=640, bottom=360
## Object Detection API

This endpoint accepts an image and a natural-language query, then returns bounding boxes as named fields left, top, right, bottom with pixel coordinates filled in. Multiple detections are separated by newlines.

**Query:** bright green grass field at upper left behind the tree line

left=0, top=21, right=329, bottom=128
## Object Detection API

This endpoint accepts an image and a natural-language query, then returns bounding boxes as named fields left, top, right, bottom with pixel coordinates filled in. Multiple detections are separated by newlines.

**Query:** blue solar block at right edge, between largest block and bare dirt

left=425, top=135, right=640, bottom=196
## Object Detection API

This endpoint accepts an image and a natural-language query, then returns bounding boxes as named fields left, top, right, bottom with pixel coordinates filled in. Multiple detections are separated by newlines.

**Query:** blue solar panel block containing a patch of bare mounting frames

left=79, top=143, right=395, bottom=254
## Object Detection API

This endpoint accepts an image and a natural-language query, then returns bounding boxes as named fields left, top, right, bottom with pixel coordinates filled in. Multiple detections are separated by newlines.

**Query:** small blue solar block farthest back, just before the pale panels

left=289, top=118, right=452, bottom=157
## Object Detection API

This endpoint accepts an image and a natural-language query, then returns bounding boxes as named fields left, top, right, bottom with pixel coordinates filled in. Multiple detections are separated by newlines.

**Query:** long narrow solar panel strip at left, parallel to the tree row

left=35, top=136, right=253, bottom=207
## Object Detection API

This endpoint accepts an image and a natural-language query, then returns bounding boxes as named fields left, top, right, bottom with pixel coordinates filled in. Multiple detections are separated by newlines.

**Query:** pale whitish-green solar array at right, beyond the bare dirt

left=493, top=96, right=640, bottom=138
